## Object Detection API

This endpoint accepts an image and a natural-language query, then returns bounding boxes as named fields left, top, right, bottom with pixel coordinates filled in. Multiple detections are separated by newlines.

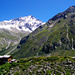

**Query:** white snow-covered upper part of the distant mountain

left=0, top=15, right=43, bottom=32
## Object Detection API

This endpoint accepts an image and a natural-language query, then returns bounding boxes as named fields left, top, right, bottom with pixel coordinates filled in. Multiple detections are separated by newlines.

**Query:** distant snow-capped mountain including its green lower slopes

left=0, top=15, right=43, bottom=54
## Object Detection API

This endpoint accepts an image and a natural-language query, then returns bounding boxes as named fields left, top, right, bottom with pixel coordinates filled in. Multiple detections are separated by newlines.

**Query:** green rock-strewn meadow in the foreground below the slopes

left=0, top=57, right=75, bottom=75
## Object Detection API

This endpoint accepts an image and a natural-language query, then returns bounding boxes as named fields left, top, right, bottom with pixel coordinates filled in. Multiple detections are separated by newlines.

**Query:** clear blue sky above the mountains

left=0, top=0, right=75, bottom=22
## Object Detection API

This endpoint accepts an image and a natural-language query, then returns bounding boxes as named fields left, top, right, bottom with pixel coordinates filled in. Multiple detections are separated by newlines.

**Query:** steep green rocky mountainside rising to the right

left=11, top=6, right=75, bottom=58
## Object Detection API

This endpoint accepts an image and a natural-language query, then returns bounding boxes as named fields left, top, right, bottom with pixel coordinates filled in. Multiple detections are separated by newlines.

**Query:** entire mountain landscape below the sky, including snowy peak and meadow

left=0, top=6, right=75, bottom=75
